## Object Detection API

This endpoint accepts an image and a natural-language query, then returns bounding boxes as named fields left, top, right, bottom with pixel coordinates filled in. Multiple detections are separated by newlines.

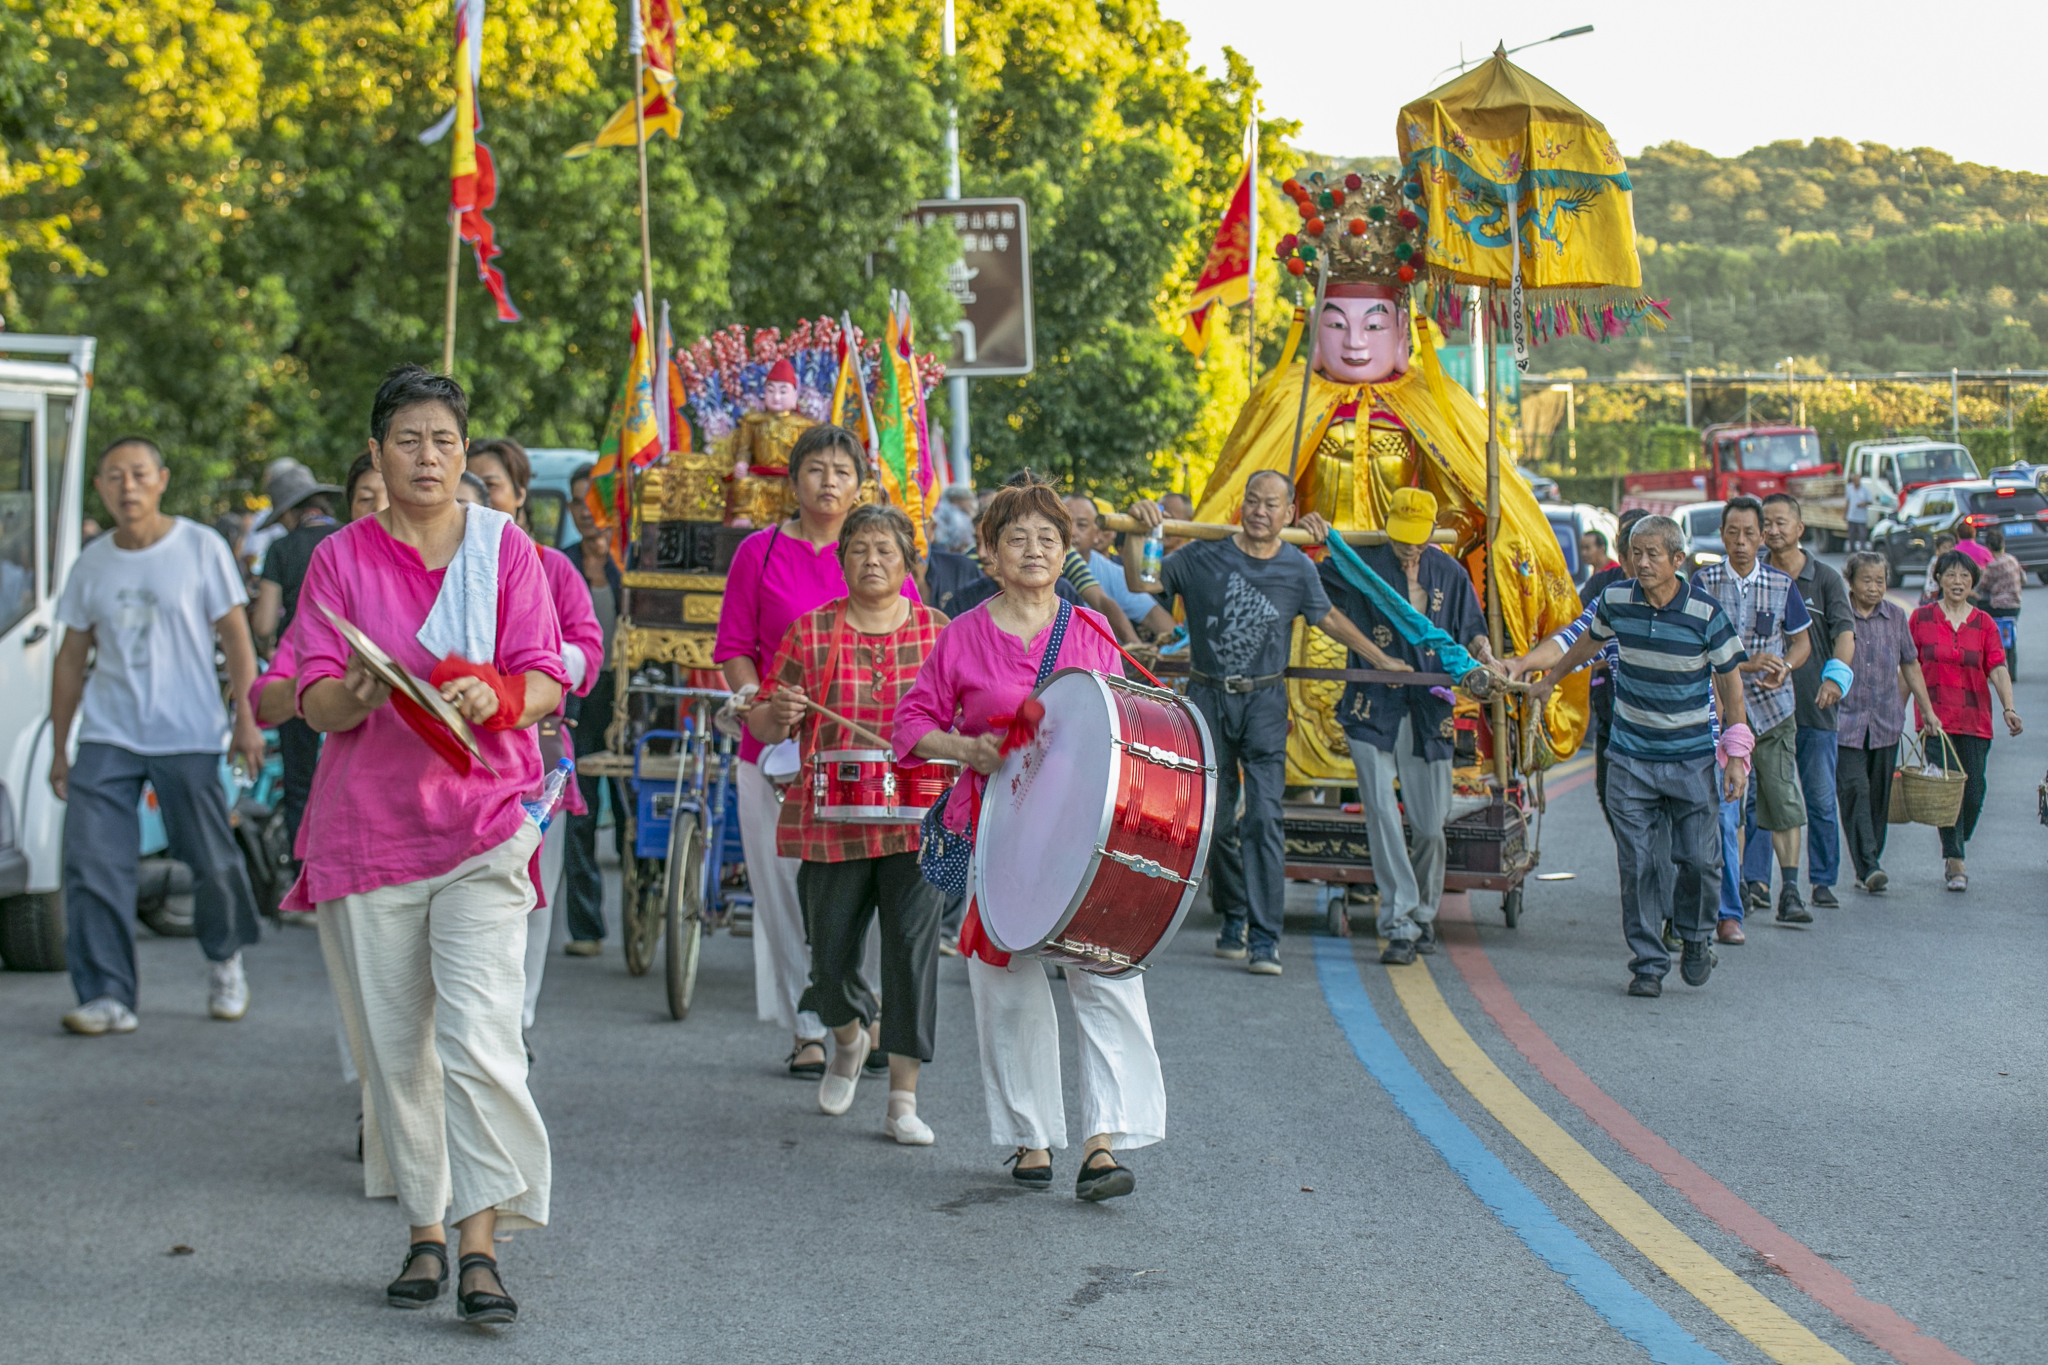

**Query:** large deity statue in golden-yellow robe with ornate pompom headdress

left=1194, top=174, right=1587, bottom=786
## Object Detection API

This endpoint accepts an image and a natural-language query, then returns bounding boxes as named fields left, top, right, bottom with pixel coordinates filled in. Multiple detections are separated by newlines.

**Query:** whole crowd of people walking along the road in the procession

left=49, top=366, right=2021, bottom=1322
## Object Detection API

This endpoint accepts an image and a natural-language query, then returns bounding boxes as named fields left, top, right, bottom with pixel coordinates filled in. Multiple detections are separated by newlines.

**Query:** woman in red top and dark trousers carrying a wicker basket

left=1909, top=551, right=2021, bottom=890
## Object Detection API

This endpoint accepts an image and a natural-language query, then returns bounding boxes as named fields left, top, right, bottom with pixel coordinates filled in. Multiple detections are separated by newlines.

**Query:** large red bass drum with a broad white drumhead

left=973, top=669, right=1217, bottom=976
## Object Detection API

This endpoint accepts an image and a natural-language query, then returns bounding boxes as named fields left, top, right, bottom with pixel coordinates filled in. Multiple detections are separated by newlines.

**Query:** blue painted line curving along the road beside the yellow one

left=1315, top=937, right=1726, bottom=1365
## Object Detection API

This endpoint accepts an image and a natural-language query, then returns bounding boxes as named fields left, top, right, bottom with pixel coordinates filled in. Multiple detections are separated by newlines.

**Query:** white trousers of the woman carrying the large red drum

left=967, top=956, right=1165, bottom=1150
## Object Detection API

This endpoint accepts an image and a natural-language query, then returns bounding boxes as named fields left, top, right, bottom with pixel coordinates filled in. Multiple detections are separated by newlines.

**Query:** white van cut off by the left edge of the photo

left=0, top=332, right=94, bottom=972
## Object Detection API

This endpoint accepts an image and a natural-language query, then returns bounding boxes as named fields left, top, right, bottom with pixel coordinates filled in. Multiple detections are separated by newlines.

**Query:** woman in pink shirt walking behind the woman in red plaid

left=713, top=424, right=918, bottom=1081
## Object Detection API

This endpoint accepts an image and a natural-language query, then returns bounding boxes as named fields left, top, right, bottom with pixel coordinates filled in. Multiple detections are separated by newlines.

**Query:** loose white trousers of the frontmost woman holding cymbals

left=319, top=821, right=551, bottom=1230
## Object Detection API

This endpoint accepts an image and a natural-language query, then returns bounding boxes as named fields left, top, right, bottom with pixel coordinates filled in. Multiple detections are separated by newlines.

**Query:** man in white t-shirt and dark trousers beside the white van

left=49, top=436, right=264, bottom=1033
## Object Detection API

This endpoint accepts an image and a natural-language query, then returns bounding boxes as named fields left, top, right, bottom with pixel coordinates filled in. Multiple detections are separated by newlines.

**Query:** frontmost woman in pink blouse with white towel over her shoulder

left=291, top=364, right=567, bottom=1322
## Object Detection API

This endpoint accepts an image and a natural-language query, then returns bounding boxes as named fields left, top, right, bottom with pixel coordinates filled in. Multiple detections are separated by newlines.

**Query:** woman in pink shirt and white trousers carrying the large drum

left=893, top=483, right=1165, bottom=1199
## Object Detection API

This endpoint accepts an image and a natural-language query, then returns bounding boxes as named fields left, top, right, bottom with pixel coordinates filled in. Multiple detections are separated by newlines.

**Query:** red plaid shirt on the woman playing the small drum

left=768, top=598, right=946, bottom=864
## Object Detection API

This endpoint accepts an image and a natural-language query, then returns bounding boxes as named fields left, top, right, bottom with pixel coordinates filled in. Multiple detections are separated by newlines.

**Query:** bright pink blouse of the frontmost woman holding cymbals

left=287, top=516, right=569, bottom=909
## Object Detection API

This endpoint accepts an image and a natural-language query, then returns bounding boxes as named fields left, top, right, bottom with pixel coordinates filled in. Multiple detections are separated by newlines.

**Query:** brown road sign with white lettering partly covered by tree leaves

left=907, top=199, right=1036, bottom=377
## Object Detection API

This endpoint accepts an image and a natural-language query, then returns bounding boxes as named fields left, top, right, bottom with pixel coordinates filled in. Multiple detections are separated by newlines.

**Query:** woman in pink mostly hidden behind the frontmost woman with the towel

left=467, top=436, right=604, bottom=1029
